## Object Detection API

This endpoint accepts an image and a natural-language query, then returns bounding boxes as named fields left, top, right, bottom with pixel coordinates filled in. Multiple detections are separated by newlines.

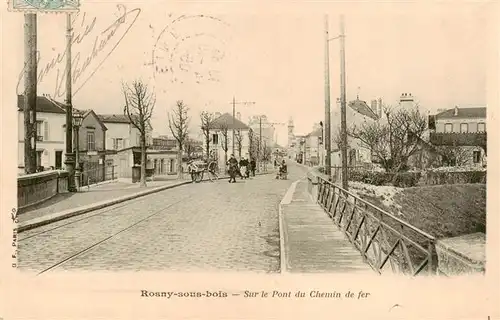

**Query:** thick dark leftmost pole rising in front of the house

left=23, top=13, right=37, bottom=174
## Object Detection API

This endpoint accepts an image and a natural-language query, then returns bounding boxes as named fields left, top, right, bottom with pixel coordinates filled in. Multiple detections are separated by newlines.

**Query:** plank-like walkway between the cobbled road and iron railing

left=280, top=180, right=373, bottom=273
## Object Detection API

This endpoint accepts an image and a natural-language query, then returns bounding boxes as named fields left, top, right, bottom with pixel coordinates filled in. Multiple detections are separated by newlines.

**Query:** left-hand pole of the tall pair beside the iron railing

left=324, top=15, right=332, bottom=179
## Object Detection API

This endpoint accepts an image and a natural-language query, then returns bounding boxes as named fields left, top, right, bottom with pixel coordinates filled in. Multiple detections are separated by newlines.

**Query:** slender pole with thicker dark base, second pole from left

left=64, top=13, right=79, bottom=192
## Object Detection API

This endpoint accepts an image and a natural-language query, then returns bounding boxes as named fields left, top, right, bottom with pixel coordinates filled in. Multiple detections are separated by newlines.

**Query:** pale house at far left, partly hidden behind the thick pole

left=17, top=95, right=66, bottom=173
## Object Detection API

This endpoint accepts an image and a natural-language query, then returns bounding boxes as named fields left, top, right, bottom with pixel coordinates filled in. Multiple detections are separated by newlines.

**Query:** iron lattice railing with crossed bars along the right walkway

left=309, top=177, right=437, bottom=276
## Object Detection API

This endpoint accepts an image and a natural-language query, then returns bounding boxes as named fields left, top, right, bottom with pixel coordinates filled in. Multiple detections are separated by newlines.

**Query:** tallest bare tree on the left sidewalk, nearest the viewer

left=122, top=80, right=156, bottom=187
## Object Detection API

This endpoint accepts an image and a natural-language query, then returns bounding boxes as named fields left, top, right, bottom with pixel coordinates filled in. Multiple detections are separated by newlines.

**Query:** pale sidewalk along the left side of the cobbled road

left=19, top=177, right=190, bottom=223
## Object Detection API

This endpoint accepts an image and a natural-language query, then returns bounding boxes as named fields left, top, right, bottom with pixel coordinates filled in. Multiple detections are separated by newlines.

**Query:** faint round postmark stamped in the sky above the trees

left=152, top=15, right=228, bottom=83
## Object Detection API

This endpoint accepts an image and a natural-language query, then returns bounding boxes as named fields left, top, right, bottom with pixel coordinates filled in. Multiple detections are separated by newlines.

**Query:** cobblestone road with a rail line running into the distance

left=19, top=167, right=305, bottom=272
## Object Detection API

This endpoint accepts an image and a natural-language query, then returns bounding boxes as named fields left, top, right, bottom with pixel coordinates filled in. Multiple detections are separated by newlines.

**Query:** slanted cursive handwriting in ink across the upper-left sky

left=17, top=4, right=141, bottom=98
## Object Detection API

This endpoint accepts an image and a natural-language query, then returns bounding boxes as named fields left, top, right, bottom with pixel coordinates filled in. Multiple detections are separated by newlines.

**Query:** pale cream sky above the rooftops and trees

left=2, top=1, right=495, bottom=144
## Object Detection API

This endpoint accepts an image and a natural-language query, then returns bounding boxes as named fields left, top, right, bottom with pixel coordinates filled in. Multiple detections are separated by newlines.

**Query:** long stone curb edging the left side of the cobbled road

left=14, top=172, right=271, bottom=233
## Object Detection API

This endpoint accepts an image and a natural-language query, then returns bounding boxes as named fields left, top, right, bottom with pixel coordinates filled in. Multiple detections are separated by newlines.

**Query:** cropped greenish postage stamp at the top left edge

left=9, top=0, right=80, bottom=13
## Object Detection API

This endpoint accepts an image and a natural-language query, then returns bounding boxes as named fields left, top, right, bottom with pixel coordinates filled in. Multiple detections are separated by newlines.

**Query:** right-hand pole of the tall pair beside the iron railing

left=340, top=15, right=348, bottom=190
